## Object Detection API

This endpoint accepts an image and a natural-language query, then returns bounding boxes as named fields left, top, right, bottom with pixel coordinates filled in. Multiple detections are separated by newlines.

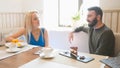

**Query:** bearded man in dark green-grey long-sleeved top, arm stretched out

left=69, top=7, right=115, bottom=56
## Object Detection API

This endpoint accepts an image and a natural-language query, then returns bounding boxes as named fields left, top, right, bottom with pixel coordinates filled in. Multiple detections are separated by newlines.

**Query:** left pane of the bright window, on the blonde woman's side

left=43, top=0, right=58, bottom=27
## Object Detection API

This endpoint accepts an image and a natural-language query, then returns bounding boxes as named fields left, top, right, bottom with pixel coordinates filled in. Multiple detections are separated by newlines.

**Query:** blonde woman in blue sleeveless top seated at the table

left=6, top=11, right=48, bottom=47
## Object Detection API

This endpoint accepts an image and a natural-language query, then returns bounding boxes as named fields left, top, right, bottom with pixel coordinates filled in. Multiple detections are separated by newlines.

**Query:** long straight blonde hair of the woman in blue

left=24, top=11, right=38, bottom=42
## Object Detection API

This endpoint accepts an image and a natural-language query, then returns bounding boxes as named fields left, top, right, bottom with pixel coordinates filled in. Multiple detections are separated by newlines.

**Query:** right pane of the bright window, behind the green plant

left=58, top=0, right=78, bottom=26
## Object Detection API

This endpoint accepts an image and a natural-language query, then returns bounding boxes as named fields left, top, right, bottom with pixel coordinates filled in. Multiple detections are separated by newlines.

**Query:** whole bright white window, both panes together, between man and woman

left=43, top=0, right=78, bottom=26
